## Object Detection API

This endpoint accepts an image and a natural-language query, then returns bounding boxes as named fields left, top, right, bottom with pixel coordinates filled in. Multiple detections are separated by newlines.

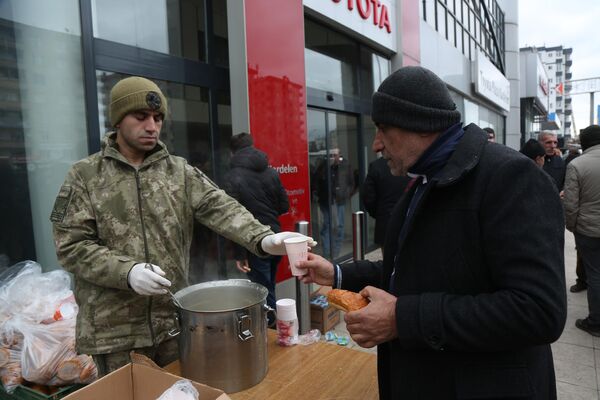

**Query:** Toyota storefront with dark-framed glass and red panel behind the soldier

left=0, top=0, right=404, bottom=281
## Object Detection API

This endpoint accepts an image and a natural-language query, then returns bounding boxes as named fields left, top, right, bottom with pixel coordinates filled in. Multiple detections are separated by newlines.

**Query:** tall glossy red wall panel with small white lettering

left=245, top=0, right=310, bottom=281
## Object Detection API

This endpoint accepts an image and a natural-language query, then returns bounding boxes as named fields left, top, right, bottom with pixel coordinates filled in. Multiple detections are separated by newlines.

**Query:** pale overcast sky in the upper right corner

left=519, top=0, right=600, bottom=131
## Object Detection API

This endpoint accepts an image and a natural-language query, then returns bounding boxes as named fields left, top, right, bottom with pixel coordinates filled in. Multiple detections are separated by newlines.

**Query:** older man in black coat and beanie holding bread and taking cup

left=298, top=67, right=567, bottom=400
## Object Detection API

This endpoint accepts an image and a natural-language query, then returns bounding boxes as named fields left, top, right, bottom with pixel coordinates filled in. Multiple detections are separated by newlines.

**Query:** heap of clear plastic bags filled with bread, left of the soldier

left=0, top=261, right=98, bottom=391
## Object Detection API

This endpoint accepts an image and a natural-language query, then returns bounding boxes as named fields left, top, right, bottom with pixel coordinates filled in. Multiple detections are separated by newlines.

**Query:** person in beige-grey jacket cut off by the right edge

left=564, top=125, right=600, bottom=336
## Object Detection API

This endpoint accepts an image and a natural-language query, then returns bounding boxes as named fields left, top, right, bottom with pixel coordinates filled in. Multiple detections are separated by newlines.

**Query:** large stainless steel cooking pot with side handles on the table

left=175, top=279, right=269, bottom=393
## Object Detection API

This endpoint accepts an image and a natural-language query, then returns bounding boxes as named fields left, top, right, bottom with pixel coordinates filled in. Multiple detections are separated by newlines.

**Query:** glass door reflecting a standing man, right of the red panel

left=307, top=108, right=360, bottom=260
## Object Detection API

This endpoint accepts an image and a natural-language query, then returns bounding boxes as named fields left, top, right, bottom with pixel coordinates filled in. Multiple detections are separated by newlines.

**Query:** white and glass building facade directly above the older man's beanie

left=420, top=0, right=519, bottom=148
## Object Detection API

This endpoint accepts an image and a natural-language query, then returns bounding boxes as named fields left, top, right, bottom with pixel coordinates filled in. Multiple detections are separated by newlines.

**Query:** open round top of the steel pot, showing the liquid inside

left=175, top=279, right=269, bottom=313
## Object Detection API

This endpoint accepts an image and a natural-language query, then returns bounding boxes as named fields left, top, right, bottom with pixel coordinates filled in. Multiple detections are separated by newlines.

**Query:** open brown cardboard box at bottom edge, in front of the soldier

left=64, top=355, right=231, bottom=400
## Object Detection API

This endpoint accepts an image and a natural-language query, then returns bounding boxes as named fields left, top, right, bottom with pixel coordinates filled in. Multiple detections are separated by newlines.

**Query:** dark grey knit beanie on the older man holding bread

left=371, top=67, right=460, bottom=132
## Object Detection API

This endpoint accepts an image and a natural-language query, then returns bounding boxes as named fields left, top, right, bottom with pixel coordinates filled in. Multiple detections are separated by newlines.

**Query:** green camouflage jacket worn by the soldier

left=50, top=132, right=272, bottom=354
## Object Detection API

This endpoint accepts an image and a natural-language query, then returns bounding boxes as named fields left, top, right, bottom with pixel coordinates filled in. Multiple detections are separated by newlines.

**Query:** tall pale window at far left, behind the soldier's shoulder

left=0, top=0, right=87, bottom=269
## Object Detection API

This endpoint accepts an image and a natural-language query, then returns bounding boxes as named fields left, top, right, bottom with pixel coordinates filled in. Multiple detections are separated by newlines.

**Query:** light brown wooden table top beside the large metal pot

left=165, top=329, right=379, bottom=400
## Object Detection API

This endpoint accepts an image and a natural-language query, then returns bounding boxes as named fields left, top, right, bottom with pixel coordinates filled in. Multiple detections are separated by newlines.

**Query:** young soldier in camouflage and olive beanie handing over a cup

left=50, top=77, right=316, bottom=374
